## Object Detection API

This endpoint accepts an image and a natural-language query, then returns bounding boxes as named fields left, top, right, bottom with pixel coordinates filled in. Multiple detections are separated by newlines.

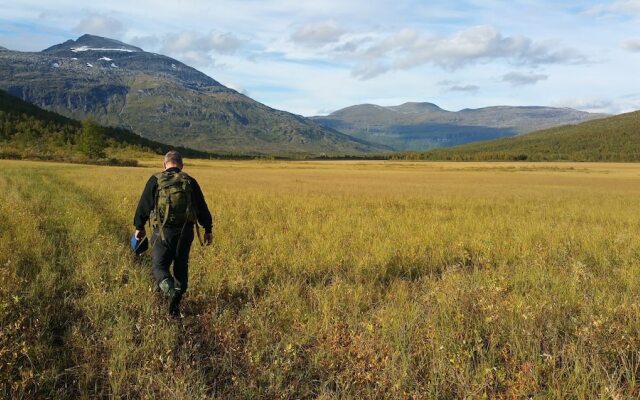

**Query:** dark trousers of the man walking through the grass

left=151, top=224, right=193, bottom=293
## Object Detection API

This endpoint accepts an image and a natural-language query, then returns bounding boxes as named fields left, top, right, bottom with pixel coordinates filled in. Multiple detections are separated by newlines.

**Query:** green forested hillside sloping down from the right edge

left=420, top=111, right=640, bottom=162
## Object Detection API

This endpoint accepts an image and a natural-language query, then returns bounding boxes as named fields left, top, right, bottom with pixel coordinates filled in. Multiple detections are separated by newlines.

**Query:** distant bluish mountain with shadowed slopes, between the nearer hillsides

left=312, top=103, right=606, bottom=150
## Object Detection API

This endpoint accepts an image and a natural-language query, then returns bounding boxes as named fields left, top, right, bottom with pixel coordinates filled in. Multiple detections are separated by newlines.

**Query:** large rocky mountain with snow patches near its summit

left=0, top=35, right=388, bottom=155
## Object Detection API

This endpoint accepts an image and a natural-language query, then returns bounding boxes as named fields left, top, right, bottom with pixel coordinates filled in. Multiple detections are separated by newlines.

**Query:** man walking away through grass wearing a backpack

left=133, top=151, right=213, bottom=317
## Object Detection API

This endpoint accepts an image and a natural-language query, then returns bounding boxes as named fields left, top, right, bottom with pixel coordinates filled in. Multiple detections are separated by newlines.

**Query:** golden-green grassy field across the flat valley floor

left=0, top=159, right=640, bottom=399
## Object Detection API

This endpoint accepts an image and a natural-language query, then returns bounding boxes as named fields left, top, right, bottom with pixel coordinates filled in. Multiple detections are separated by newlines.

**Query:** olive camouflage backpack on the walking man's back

left=153, top=171, right=196, bottom=240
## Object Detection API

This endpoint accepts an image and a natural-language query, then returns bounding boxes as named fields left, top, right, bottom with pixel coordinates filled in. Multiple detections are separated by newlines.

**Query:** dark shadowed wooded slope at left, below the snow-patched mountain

left=0, top=90, right=210, bottom=163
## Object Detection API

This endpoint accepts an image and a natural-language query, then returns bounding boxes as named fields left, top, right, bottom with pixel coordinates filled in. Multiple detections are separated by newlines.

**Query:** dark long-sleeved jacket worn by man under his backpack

left=133, top=167, right=213, bottom=233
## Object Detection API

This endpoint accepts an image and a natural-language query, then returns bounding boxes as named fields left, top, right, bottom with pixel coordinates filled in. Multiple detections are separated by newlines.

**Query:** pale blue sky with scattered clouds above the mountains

left=0, top=0, right=640, bottom=116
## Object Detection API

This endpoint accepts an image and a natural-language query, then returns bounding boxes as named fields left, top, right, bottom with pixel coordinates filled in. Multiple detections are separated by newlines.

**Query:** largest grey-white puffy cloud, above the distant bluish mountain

left=344, top=25, right=587, bottom=80
